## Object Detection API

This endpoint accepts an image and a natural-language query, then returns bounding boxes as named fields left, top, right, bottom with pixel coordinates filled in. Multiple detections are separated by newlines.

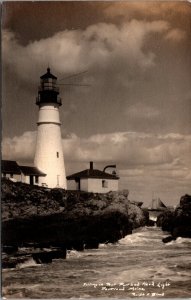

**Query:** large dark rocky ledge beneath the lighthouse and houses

left=2, top=179, right=148, bottom=268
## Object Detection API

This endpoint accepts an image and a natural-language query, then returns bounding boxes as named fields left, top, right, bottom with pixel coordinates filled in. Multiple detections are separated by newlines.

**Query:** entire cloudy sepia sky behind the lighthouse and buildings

left=2, top=1, right=191, bottom=205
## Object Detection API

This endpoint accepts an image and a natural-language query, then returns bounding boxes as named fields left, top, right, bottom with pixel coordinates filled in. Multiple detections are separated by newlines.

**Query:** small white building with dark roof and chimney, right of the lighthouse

left=66, top=162, right=119, bottom=193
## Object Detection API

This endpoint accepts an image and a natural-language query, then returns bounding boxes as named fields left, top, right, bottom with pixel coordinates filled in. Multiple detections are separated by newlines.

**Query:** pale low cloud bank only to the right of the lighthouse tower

left=64, top=132, right=191, bottom=168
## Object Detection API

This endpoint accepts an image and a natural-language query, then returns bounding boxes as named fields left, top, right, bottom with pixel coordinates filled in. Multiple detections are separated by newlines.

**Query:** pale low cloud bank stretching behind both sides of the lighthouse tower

left=2, top=132, right=191, bottom=169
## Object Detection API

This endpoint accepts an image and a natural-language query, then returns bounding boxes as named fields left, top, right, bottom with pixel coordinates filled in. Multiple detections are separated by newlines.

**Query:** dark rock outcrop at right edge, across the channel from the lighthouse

left=157, top=194, right=191, bottom=239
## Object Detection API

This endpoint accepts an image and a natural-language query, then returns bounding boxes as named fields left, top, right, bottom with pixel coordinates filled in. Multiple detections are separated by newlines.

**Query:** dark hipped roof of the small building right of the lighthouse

left=66, top=169, right=119, bottom=180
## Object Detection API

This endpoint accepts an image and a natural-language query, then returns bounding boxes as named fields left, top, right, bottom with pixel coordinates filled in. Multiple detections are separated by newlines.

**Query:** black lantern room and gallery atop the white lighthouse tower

left=36, top=68, right=62, bottom=105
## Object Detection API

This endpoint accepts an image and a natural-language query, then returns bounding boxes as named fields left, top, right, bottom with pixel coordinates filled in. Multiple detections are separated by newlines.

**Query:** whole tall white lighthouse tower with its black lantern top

left=34, top=68, right=66, bottom=189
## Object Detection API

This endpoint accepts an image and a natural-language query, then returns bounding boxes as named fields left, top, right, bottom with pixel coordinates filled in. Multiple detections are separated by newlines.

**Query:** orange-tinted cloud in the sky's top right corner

left=104, top=1, right=188, bottom=42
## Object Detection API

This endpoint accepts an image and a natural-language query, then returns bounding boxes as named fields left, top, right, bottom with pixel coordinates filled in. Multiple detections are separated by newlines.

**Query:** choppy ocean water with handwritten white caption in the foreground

left=2, top=227, right=191, bottom=299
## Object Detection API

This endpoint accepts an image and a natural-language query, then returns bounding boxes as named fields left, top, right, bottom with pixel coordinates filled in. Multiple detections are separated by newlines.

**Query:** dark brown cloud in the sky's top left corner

left=3, top=1, right=108, bottom=45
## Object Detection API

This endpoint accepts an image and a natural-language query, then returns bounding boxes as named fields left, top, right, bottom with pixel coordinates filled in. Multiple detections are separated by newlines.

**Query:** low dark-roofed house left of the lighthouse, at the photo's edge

left=1, top=160, right=46, bottom=185
